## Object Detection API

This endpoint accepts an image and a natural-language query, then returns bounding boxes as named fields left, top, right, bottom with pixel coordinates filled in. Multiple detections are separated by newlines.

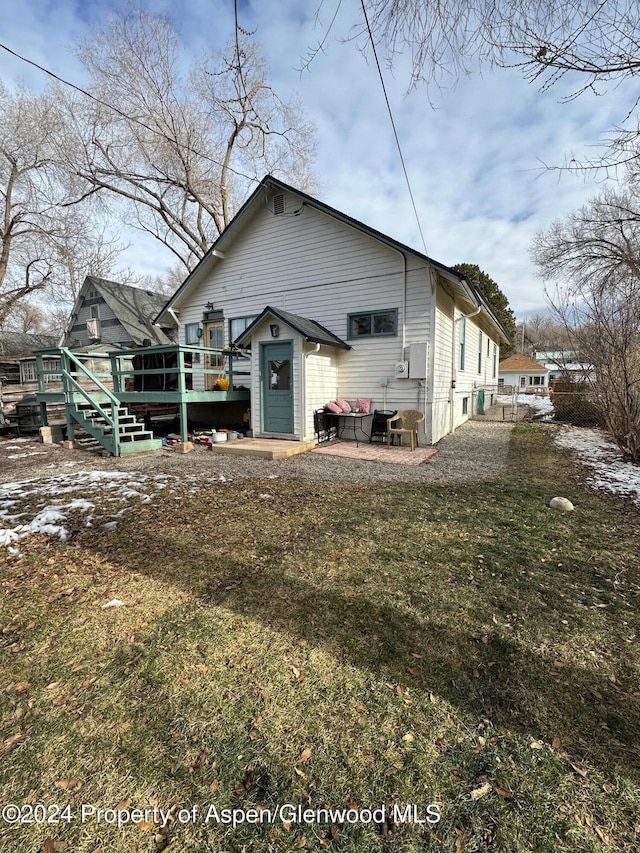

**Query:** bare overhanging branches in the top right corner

left=358, top=0, right=640, bottom=168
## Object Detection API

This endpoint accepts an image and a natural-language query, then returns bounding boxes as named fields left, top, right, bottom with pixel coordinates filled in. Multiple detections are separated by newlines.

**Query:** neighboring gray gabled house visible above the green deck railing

left=59, top=275, right=173, bottom=350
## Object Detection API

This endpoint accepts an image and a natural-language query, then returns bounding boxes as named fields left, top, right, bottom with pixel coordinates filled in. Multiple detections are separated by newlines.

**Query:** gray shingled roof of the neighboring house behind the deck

left=72, top=275, right=173, bottom=346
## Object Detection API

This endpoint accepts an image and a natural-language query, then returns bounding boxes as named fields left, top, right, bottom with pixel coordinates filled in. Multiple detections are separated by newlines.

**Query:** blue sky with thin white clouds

left=0, top=0, right=634, bottom=318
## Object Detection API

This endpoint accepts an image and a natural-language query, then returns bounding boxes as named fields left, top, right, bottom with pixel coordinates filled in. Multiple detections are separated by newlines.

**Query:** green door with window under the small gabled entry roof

left=260, top=341, right=293, bottom=435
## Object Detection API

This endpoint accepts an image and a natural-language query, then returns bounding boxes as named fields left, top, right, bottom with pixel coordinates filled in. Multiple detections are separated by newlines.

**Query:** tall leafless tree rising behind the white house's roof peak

left=60, top=11, right=314, bottom=271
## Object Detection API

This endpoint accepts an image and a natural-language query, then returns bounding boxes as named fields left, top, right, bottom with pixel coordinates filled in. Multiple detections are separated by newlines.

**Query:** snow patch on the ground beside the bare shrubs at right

left=556, top=429, right=640, bottom=506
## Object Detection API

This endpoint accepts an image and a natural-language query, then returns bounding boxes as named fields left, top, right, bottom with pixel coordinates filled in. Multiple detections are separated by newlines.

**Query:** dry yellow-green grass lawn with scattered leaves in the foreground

left=0, top=426, right=640, bottom=853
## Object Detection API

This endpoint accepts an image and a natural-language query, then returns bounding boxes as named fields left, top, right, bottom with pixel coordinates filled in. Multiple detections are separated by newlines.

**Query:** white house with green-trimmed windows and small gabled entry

left=155, top=176, right=506, bottom=443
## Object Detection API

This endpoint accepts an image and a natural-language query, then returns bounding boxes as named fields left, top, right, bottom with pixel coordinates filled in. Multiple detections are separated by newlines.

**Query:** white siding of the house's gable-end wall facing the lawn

left=176, top=200, right=432, bottom=434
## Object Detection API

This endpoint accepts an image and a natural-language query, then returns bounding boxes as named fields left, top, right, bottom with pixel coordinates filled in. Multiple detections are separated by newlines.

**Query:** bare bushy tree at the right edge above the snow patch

left=534, top=188, right=640, bottom=463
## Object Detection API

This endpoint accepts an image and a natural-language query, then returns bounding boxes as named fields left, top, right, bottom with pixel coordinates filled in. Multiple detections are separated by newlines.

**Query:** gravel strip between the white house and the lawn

left=0, top=421, right=513, bottom=484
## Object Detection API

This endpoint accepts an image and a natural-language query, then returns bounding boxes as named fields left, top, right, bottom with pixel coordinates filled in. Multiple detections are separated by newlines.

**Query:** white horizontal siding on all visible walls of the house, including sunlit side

left=172, top=183, right=498, bottom=443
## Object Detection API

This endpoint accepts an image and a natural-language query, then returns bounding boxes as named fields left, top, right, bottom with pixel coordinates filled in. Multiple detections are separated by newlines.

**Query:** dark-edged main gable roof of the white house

left=154, top=175, right=509, bottom=342
